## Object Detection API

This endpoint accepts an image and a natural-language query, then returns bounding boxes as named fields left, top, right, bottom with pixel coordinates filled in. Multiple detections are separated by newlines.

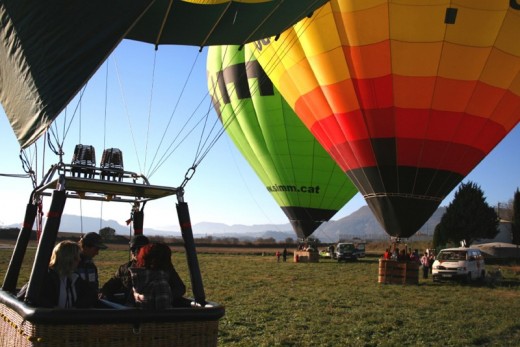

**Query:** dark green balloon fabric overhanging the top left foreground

left=0, top=0, right=326, bottom=148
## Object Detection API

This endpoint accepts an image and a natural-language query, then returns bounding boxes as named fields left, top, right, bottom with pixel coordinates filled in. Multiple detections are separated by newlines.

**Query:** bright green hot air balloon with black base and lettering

left=207, top=46, right=357, bottom=239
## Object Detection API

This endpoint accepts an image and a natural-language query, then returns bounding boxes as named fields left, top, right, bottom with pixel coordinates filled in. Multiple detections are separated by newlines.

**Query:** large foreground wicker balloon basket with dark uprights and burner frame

left=0, top=163, right=225, bottom=347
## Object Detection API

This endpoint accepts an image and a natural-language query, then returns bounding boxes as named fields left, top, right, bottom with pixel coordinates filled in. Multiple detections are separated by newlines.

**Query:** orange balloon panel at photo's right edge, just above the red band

left=480, top=49, right=520, bottom=89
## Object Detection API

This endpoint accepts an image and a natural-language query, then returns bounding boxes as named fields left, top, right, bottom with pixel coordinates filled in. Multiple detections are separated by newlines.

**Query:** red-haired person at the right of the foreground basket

left=129, top=242, right=189, bottom=309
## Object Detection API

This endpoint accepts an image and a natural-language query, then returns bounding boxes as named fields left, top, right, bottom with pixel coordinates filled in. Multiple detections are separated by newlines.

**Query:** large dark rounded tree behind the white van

left=440, top=182, right=499, bottom=245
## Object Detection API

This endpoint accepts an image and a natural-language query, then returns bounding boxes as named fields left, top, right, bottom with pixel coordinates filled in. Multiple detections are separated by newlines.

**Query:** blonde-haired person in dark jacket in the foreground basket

left=36, top=241, right=97, bottom=308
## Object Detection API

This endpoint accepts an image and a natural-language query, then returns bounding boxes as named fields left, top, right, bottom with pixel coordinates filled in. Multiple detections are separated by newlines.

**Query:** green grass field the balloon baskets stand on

left=0, top=247, right=520, bottom=346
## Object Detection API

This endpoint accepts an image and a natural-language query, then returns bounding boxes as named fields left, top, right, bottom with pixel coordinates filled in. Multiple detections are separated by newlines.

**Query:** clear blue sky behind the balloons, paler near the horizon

left=0, top=41, right=520, bottom=229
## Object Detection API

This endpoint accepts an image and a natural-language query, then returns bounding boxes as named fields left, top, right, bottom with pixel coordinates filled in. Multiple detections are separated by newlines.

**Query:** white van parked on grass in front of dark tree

left=432, top=247, right=486, bottom=282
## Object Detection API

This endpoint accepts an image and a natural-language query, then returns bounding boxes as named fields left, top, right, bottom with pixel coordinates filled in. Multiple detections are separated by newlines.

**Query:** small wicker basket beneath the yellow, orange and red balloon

left=378, top=259, right=420, bottom=284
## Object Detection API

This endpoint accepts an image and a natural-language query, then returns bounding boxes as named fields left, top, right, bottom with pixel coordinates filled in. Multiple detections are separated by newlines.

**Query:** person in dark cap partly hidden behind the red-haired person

left=101, top=235, right=150, bottom=305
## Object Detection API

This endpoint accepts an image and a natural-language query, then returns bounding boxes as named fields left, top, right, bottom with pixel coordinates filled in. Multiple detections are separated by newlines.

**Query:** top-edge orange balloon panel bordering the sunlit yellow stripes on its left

left=335, top=1, right=389, bottom=46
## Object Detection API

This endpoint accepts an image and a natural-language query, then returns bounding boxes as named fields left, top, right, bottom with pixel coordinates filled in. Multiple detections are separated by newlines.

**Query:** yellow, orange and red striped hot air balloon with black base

left=255, top=0, right=520, bottom=238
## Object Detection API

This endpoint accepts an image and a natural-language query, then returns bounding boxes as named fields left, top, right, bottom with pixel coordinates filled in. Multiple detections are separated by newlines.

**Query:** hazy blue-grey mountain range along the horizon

left=6, top=206, right=446, bottom=242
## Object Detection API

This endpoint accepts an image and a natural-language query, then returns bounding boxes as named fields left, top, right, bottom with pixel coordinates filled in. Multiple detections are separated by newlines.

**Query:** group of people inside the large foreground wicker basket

left=18, top=232, right=191, bottom=309
